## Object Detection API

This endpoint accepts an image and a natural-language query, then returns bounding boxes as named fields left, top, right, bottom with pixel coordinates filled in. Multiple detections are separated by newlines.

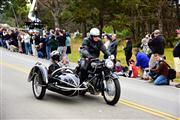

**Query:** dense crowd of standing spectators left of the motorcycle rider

left=0, top=27, right=71, bottom=63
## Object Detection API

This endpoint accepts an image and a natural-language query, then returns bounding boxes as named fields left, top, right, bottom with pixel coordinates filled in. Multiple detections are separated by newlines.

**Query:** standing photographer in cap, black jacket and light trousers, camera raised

left=148, top=30, right=165, bottom=68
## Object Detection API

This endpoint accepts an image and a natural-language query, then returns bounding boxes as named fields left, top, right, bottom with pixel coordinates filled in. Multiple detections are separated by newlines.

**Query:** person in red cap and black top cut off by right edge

left=173, top=29, right=180, bottom=76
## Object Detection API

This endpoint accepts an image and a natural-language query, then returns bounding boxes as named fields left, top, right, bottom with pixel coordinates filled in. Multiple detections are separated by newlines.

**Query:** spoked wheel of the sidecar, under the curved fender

left=32, top=71, right=46, bottom=99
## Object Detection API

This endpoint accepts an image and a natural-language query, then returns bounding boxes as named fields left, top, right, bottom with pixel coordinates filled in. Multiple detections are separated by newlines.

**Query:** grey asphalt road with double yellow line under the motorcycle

left=0, top=48, right=180, bottom=120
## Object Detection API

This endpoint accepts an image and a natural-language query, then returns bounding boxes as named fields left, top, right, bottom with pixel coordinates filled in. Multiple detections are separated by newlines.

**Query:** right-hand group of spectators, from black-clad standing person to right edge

left=113, top=30, right=180, bottom=85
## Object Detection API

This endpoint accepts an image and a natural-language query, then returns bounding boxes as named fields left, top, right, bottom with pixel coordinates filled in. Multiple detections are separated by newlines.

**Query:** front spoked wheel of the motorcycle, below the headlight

left=103, top=78, right=121, bottom=105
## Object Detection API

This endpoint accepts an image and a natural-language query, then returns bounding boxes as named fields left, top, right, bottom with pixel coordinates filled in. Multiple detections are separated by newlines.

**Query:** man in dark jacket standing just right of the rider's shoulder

left=108, top=34, right=118, bottom=63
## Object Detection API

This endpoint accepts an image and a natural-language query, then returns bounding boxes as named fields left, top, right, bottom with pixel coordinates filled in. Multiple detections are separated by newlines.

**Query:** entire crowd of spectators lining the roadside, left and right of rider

left=0, top=27, right=180, bottom=85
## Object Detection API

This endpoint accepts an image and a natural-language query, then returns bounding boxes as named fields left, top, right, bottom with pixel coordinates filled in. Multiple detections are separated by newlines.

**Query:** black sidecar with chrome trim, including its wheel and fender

left=28, top=62, right=87, bottom=99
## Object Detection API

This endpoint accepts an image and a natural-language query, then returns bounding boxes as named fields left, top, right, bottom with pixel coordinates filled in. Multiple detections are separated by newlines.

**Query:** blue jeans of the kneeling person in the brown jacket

left=154, top=75, right=168, bottom=85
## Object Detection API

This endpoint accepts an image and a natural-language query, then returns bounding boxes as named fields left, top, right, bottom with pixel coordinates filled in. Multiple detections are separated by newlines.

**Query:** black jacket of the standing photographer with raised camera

left=148, top=35, right=165, bottom=55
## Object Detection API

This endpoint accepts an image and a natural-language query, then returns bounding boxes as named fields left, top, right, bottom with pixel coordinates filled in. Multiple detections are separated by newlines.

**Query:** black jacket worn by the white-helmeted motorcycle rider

left=80, top=37, right=110, bottom=58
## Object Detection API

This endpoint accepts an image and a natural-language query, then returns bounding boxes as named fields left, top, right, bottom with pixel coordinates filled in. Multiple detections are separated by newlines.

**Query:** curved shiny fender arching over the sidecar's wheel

left=27, top=63, right=48, bottom=83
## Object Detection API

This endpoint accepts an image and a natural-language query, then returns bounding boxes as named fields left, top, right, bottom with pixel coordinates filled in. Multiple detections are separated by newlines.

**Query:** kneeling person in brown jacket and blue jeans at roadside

left=151, top=54, right=169, bottom=85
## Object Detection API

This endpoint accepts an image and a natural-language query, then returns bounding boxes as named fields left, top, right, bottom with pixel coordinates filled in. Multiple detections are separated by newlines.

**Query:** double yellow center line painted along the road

left=0, top=61, right=180, bottom=120
